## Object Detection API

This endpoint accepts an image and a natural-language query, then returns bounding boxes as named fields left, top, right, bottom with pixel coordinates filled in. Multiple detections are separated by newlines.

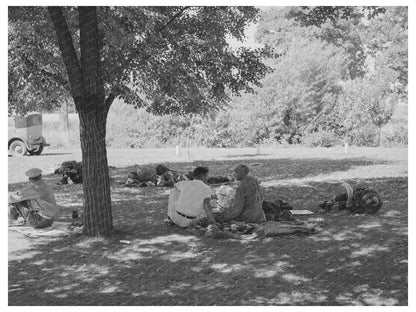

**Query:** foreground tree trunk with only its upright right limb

left=78, top=7, right=113, bottom=236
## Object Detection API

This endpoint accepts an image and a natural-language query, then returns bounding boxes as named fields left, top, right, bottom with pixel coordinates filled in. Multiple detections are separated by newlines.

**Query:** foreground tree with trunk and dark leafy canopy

left=9, top=7, right=268, bottom=235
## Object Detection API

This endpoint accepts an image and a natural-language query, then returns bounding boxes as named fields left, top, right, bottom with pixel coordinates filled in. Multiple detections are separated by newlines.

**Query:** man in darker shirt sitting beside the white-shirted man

left=215, top=165, right=266, bottom=223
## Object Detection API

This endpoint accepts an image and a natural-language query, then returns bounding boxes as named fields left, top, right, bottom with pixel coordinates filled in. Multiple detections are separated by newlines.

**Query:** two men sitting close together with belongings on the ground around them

left=166, top=164, right=304, bottom=238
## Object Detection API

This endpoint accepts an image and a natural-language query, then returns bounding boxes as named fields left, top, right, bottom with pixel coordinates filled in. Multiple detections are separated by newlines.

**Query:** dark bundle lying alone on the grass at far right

left=319, top=183, right=383, bottom=214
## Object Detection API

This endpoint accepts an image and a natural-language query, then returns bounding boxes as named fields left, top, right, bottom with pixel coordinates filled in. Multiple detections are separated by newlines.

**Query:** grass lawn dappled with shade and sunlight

left=8, top=148, right=408, bottom=305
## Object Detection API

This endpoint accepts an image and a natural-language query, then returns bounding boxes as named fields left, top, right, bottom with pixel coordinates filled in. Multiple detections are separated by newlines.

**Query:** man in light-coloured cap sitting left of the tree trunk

left=9, top=168, right=59, bottom=228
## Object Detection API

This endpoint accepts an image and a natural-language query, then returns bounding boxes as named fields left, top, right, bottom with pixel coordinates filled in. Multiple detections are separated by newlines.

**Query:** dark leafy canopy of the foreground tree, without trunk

left=9, top=6, right=269, bottom=114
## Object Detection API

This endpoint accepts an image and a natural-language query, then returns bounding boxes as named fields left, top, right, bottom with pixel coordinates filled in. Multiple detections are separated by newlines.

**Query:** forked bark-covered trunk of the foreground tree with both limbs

left=48, top=7, right=113, bottom=236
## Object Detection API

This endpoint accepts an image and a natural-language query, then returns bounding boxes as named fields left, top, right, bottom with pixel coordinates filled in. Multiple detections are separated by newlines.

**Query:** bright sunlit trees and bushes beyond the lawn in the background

left=9, top=7, right=408, bottom=147
